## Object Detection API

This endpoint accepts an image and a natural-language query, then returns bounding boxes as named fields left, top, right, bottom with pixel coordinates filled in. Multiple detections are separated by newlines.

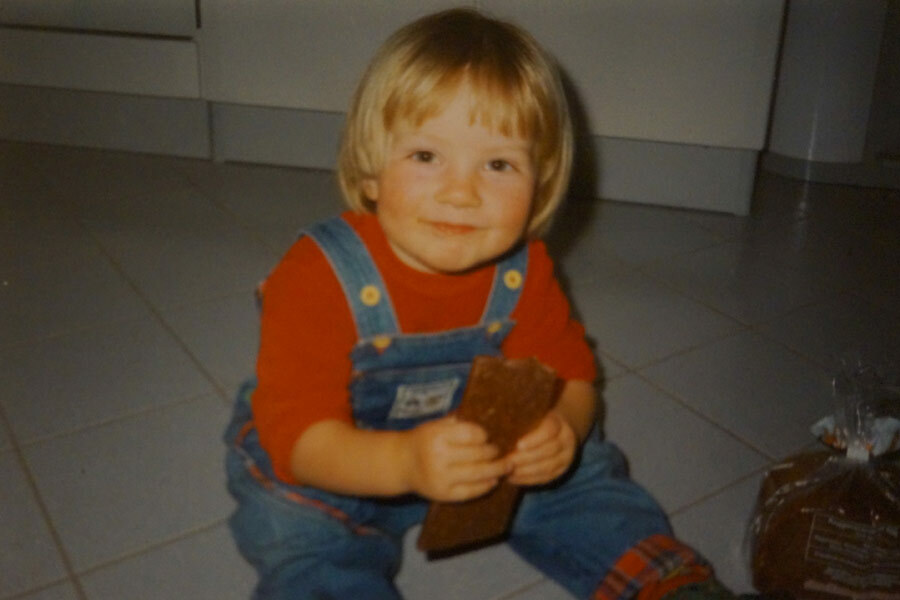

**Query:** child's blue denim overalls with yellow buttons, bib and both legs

left=225, top=218, right=669, bottom=600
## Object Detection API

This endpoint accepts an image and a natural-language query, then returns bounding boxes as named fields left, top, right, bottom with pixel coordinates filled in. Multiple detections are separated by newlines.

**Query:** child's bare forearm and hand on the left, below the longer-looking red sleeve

left=291, top=416, right=511, bottom=501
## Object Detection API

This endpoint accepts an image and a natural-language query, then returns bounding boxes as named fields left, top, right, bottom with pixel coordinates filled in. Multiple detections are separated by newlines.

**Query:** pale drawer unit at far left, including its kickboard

left=0, top=0, right=203, bottom=157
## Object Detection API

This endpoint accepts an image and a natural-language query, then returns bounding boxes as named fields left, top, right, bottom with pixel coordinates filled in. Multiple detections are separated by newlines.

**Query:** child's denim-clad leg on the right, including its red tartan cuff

left=509, top=439, right=711, bottom=600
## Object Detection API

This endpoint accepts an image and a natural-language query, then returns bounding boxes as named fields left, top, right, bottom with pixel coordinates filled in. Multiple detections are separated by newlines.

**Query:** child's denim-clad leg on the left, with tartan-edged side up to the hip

left=225, top=381, right=414, bottom=600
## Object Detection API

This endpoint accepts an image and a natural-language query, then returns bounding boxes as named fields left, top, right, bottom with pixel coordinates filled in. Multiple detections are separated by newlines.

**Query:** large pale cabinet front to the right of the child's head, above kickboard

left=481, top=0, right=784, bottom=150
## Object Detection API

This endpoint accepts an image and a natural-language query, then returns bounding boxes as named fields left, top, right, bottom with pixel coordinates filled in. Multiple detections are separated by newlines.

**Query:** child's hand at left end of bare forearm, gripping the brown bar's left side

left=407, top=416, right=510, bottom=502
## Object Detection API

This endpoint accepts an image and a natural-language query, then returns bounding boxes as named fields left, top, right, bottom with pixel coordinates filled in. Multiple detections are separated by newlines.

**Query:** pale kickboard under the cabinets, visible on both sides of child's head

left=213, top=104, right=758, bottom=215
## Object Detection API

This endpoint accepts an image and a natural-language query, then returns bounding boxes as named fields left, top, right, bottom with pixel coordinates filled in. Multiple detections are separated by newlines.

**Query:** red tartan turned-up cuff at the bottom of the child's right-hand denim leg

left=591, top=535, right=712, bottom=600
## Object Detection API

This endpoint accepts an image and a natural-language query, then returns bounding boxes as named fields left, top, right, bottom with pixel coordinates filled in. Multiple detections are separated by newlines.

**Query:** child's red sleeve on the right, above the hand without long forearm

left=503, top=241, right=597, bottom=381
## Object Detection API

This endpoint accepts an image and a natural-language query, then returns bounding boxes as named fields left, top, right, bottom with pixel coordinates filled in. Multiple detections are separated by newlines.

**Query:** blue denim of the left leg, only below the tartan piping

left=227, top=450, right=400, bottom=600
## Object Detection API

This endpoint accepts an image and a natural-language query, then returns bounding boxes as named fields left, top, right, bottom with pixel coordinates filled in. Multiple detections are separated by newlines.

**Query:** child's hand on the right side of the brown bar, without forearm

left=507, top=411, right=578, bottom=485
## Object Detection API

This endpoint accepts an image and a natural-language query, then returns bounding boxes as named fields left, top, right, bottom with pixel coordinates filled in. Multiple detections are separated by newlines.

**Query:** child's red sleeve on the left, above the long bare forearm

left=253, top=237, right=356, bottom=481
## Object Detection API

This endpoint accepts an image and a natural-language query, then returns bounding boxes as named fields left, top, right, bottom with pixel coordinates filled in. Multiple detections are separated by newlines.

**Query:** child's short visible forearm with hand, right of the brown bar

left=507, top=380, right=596, bottom=485
